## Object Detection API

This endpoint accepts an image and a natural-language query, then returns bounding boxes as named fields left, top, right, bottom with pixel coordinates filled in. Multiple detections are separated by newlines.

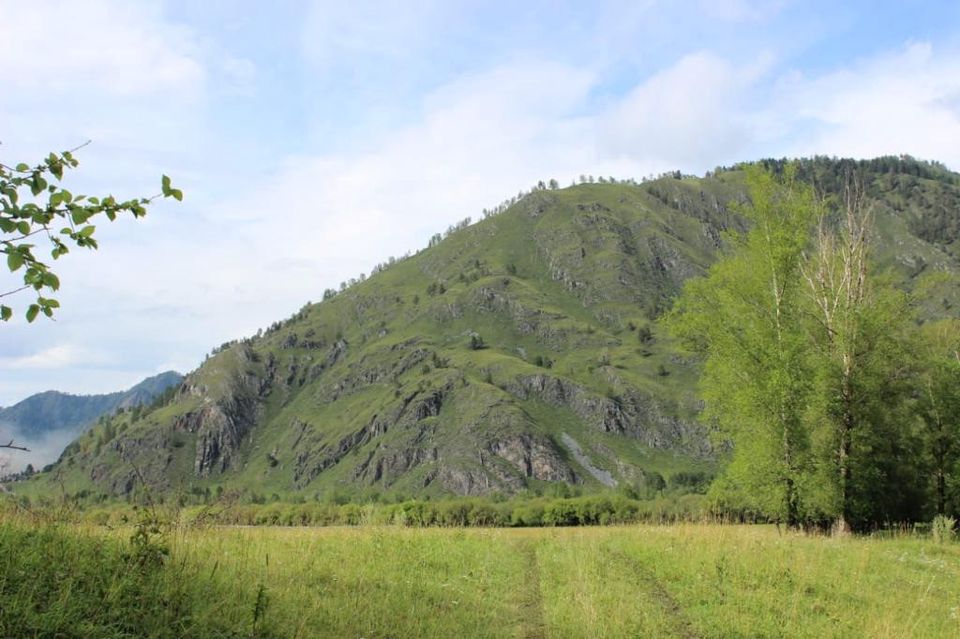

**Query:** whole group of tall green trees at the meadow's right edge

left=666, top=166, right=960, bottom=531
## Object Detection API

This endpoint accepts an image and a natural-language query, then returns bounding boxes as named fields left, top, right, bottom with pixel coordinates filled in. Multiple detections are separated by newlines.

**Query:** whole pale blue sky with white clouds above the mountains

left=0, top=0, right=960, bottom=406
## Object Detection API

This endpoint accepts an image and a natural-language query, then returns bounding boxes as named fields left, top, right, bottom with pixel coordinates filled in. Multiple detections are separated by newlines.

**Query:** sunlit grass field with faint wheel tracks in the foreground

left=0, top=521, right=960, bottom=637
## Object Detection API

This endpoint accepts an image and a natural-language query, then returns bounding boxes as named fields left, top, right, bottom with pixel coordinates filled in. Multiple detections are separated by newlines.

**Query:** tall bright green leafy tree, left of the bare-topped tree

left=667, top=166, right=820, bottom=526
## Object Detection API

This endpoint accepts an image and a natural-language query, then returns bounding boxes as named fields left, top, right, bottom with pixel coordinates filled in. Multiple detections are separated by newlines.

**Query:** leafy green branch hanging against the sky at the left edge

left=0, top=141, right=183, bottom=322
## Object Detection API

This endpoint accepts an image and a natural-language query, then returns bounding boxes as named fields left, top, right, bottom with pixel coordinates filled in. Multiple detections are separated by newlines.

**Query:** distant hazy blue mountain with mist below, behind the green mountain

left=0, top=371, right=183, bottom=469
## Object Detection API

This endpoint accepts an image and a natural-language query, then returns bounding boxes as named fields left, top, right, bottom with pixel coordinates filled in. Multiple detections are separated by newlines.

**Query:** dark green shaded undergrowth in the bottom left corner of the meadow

left=0, top=516, right=262, bottom=639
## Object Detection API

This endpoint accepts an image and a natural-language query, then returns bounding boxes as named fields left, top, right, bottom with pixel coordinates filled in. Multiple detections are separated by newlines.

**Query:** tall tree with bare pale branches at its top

left=802, top=174, right=919, bottom=533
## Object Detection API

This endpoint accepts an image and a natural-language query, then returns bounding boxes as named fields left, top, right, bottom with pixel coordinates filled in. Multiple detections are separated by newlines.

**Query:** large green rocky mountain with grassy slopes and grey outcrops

left=18, top=158, right=960, bottom=496
